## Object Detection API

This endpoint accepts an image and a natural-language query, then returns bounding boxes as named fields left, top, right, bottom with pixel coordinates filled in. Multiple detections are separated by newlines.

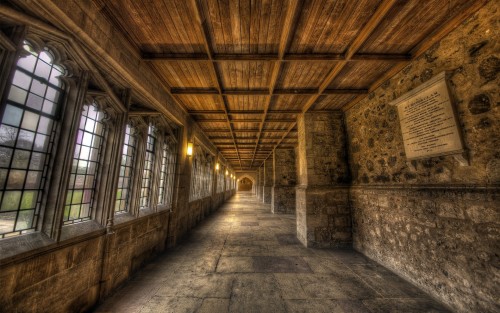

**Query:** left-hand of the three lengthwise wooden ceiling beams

left=191, top=0, right=242, bottom=169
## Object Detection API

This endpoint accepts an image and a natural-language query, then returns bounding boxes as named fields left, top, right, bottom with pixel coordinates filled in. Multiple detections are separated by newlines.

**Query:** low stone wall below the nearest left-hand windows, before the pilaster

left=0, top=211, right=169, bottom=312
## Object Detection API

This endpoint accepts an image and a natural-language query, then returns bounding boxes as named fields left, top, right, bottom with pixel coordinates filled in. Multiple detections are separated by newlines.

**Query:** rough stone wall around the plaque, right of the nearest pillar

left=346, top=1, right=500, bottom=312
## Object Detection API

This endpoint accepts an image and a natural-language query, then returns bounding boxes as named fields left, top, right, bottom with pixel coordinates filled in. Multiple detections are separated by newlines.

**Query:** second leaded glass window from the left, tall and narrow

left=64, top=102, right=105, bottom=224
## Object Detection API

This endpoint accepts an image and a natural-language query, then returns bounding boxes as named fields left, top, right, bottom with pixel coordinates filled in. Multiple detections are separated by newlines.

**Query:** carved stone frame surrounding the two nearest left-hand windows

left=0, top=25, right=131, bottom=247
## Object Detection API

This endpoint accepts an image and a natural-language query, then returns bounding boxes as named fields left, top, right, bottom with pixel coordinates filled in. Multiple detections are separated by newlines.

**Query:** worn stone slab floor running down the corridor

left=95, top=193, right=447, bottom=313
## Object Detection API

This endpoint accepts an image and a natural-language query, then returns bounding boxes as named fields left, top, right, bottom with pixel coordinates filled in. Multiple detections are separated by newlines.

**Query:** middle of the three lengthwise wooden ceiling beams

left=249, top=0, right=303, bottom=168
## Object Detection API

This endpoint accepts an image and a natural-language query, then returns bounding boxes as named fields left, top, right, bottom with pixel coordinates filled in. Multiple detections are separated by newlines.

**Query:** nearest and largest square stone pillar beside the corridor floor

left=296, top=112, right=352, bottom=248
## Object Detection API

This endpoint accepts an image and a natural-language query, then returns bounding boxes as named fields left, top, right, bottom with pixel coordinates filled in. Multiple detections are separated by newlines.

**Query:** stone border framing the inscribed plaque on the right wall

left=389, top=71, right=470, bottom=166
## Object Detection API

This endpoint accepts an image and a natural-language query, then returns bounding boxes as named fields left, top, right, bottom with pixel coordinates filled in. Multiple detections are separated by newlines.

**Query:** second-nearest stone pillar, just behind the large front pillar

left=271, top=149, right=297, bottom=214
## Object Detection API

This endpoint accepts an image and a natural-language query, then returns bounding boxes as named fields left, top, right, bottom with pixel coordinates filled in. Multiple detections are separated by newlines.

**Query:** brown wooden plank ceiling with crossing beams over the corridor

left=101, top=0, right=485, bottom=170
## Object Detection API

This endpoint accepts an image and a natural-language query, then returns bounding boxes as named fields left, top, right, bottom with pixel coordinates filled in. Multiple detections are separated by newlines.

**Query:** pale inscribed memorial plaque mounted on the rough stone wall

left=390, top=72, right=464, bottom=160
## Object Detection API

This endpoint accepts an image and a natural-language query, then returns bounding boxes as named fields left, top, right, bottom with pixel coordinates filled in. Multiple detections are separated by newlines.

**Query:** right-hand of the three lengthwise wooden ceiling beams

left=258, top=0, right=398, bottom=168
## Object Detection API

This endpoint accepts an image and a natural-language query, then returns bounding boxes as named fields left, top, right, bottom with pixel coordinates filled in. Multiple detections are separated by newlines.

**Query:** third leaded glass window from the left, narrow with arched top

left=115, top=125, right=136, bottom=212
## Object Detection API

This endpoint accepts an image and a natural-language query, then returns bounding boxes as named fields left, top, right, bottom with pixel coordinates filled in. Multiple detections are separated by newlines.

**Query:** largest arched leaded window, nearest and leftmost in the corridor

left=0, top=41, right=65, bottom=238
